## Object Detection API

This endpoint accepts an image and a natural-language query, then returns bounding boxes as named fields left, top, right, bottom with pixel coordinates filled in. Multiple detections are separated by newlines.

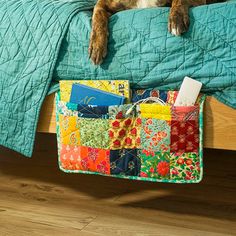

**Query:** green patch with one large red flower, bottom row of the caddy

left=139, top=150, right=170, bottom=179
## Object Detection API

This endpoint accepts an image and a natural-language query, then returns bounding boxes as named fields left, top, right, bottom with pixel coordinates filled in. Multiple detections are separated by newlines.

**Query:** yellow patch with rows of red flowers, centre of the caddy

left=109, top=118, right=142, bottom=150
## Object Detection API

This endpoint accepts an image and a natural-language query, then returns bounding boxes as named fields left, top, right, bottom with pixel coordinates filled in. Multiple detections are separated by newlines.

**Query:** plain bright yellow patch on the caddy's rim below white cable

left=140, top=104, right=171, bottom=121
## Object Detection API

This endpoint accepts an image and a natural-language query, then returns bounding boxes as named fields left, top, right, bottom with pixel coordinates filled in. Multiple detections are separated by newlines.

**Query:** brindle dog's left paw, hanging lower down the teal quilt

left=89, top=32, right=107, bottom=65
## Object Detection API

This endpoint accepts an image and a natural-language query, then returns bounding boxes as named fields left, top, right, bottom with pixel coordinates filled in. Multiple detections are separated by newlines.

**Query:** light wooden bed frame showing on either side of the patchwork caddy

left=37, top=94, right=236, bottom=150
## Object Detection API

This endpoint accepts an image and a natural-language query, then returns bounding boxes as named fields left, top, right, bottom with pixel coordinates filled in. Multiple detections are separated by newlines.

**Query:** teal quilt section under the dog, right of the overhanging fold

left=54, top=0, right=236, bottom=108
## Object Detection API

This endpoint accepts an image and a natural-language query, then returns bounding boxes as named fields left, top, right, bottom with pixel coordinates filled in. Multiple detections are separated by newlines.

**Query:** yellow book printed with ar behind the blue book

left=60, top=80, right=130, bottom=102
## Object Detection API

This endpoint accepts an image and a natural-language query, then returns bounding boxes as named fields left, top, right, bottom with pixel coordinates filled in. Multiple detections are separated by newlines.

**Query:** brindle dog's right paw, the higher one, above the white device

left=168, top=8, right=189, bottom=36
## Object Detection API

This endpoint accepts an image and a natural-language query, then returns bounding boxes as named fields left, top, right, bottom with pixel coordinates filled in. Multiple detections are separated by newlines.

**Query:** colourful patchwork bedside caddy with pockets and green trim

left=56, top=90, right=205, bottom=183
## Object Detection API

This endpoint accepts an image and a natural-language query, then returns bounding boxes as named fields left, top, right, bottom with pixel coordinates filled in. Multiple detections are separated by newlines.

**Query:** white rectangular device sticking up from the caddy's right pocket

left=174, top=77, right=202, bottom=106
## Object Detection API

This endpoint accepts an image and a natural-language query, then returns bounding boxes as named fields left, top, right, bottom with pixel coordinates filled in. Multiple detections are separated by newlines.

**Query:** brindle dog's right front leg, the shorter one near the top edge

left=168, top=0, right=206, bottom=36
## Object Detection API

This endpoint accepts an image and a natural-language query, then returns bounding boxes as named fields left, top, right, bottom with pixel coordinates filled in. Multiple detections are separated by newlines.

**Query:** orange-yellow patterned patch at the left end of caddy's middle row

left=59, top=114, right=80, bottom=145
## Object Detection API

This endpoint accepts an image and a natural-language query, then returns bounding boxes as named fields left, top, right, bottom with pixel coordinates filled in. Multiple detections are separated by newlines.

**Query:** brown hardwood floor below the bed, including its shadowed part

left=0, top=134, right=236, bottom=236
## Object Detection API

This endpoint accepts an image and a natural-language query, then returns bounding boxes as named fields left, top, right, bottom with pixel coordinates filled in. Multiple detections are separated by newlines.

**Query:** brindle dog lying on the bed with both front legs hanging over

left=89, top=0, right=225, bottom=65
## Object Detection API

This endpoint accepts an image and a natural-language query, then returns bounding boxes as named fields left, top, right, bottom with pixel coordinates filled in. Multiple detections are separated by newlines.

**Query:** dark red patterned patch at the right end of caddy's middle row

left=170, top=120, right=199, bottom=153
